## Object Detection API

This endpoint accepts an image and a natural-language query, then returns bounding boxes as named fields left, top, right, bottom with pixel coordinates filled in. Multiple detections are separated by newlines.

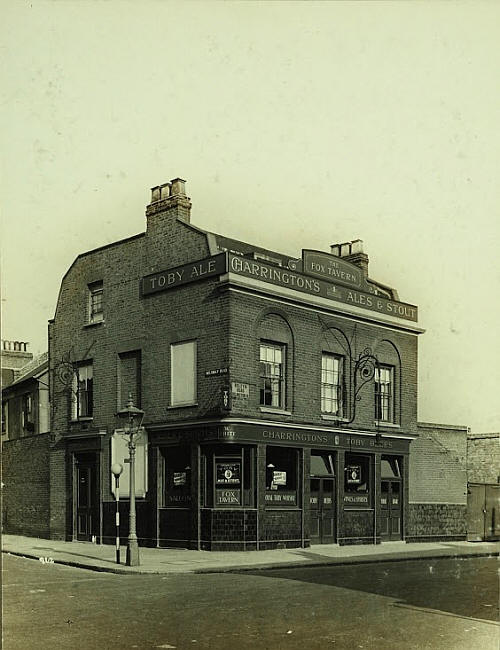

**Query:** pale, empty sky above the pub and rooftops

left=0, top=0, right=500, bottom=432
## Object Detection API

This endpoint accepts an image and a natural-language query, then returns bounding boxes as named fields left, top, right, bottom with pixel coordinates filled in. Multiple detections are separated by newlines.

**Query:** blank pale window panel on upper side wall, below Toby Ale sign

left=170, top=339, right=198, bottom=407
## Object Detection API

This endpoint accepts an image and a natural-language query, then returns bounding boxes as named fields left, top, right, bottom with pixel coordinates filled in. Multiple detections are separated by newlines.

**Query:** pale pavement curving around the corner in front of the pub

left=1, top=535, right=500, bottom=574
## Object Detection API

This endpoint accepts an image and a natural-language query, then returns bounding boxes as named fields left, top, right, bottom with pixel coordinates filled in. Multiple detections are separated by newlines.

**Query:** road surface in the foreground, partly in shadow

left=3, top=555, right=500, bottom=650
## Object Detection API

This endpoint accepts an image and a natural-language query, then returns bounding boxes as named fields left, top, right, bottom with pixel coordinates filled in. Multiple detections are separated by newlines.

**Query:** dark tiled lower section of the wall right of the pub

left=406, top=503, right=467, bottom=542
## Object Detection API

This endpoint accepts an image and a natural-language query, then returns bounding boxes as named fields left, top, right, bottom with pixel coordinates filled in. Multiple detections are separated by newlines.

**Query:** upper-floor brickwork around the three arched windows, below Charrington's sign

left=229, top=292, right=417, bottom=433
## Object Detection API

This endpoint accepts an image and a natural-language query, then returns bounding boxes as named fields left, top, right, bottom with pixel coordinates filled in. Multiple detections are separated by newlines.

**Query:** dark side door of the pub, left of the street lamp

left=74, top=453, right=99, bottom=542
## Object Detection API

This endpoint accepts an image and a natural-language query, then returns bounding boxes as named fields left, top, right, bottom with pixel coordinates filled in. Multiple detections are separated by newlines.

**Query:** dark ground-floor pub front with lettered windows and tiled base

left=149, top=423, right=410, bottom=550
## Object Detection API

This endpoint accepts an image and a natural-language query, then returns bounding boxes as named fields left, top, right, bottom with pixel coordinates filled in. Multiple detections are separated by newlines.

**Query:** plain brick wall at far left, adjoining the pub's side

left=2, top=433, right=50, bottom=538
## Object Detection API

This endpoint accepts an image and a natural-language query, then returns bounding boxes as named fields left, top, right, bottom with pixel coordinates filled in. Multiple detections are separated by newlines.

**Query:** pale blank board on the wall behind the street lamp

left=109, top=429, right=148, bottom=499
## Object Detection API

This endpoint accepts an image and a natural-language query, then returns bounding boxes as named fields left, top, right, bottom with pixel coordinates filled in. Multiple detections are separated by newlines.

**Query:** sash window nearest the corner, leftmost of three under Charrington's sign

left=259, top=341, right=286, bottom=409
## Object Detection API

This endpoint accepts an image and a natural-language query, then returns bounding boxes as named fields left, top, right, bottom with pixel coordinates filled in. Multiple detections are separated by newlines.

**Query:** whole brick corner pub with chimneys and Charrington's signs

left=49, top=179, right=423, bottom=550
